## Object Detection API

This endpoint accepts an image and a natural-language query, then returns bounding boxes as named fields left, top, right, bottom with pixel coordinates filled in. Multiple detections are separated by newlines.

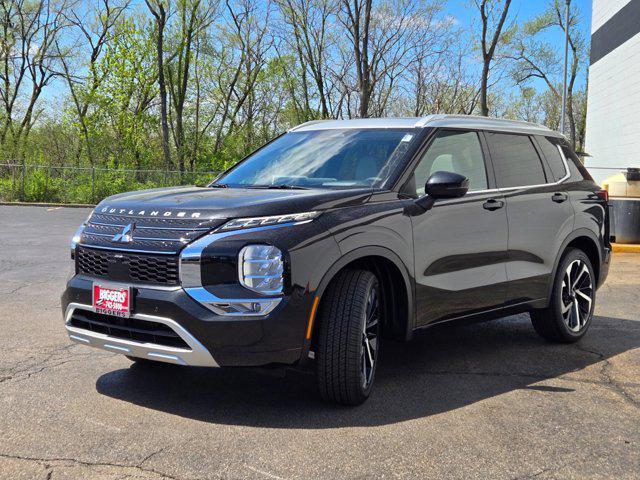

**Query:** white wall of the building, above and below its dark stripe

left=585, top=0, right=640, bottom=182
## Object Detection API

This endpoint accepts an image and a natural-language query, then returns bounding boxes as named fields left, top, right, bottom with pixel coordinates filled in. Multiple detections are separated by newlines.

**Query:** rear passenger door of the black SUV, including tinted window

left=485, top=132, right=574, bottom=305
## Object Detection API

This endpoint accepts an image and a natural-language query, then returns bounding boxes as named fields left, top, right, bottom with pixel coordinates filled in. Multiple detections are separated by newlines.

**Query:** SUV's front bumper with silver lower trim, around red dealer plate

left=62, top=275, right=311, bottom=367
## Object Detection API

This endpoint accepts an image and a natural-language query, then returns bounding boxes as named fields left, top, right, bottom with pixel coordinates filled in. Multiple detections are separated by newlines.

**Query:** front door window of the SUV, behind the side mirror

left=413, top=130, right=487, bottom=196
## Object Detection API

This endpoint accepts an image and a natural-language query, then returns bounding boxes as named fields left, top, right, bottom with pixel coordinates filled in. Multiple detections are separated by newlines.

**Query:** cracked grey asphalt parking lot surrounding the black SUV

left=0, top=206, right=640, bottom=480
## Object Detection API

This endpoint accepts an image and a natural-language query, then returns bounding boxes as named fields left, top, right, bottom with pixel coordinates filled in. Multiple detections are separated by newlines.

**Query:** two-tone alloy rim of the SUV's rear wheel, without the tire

left=561, top=260, right=593, bottom=332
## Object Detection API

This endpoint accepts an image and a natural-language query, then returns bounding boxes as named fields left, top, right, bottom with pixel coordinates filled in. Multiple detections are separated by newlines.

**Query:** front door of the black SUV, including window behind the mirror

left=411, top=130, right=507, bottom=326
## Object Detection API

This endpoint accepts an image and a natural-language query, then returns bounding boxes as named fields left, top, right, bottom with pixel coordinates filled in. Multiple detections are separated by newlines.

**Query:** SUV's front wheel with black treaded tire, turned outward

left=316, top=270, right=384, bottom=405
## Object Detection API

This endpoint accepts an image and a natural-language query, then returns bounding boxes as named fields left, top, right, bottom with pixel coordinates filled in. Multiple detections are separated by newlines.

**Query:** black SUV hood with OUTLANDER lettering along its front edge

left=95, top=187, right=372, bottom=219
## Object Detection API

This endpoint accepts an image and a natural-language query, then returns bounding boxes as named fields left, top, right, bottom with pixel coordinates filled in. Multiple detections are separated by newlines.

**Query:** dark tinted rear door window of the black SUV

left=487, top=132, right=547, bottom=188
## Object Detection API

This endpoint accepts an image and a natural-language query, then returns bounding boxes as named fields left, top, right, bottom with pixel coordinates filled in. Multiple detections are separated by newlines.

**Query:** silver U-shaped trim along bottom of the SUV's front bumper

left=64, top=303, right=219, bottom=367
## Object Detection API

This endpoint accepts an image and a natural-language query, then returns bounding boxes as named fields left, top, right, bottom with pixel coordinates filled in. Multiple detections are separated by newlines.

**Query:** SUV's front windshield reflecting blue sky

left=212, top=129, right=415, bottom=188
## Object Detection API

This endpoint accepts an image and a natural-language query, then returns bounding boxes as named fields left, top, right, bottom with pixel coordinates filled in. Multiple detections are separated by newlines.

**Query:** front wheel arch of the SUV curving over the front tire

left=314, top=246, right=414, bottom=340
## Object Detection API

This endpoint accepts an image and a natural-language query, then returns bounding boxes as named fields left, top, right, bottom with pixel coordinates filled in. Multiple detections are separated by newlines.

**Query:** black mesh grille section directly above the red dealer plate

left=76, top=246, right=179, bottom=286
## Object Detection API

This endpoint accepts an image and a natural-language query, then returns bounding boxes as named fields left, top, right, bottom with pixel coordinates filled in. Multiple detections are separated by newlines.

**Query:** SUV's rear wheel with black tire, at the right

left=530, top=248, right=596, bottom=343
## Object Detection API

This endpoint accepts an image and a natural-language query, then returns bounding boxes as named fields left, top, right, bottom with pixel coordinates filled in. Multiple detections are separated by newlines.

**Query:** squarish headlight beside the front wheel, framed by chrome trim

left=238, top=245, right=284, bottom=295
